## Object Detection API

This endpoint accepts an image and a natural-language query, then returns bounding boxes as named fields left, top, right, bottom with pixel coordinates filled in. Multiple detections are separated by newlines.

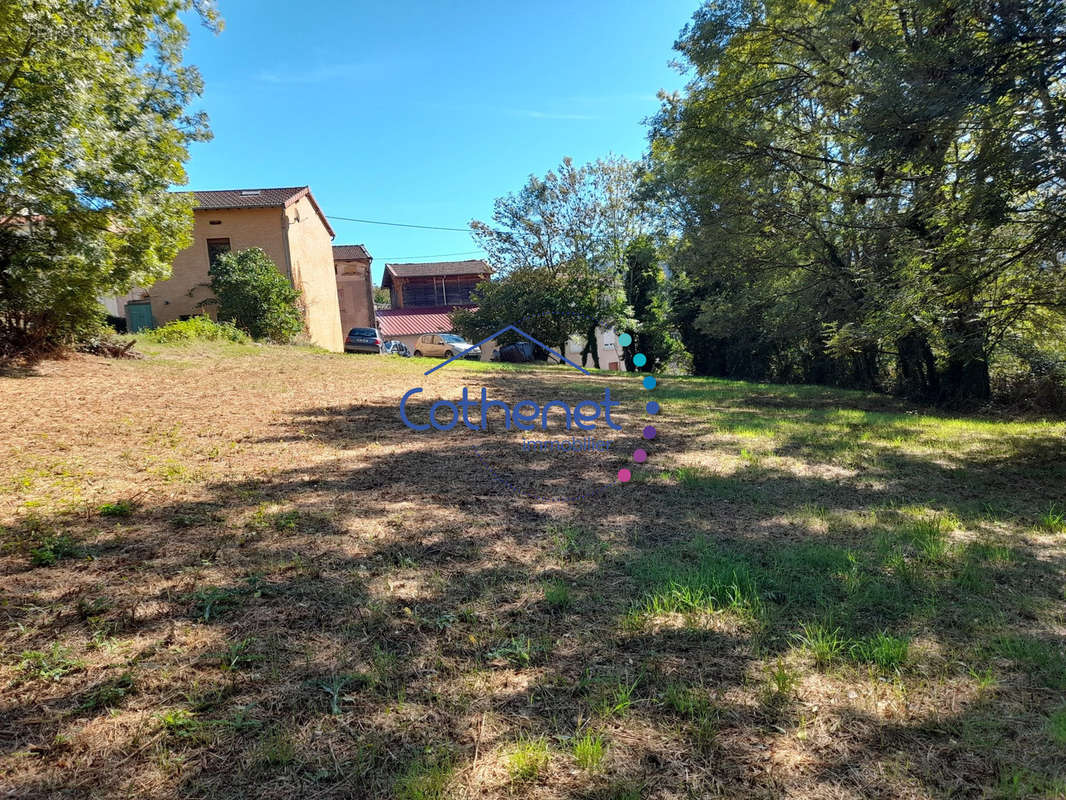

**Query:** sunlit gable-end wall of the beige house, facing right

left=284, top=195, right=344, bottom=353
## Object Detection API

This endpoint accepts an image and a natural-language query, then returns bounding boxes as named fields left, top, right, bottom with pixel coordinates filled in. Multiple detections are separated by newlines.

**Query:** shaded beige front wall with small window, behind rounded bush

left=147, top=208, right=286, bottom=325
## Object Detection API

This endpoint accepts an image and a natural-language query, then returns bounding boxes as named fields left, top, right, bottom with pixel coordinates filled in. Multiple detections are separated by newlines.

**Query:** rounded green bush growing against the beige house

left=208, top=247, right=304, bottom=345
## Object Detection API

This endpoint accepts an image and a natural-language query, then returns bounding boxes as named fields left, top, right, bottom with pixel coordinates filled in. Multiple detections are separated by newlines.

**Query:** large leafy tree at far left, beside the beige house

left=0, top=0, right=221, bottom=357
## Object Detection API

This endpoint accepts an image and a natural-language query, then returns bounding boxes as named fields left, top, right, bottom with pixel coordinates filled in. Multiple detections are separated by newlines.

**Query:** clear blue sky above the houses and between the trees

left=187, top=0, right=698, bottom=282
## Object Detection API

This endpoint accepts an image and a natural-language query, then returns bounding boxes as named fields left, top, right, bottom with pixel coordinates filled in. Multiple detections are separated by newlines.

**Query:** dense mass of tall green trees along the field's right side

left=650, top=0, right=1066, bottom=401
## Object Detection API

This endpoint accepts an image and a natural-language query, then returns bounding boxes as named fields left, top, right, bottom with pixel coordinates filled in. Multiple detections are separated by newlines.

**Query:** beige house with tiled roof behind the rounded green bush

left=123, top=186, right=344, bottom=352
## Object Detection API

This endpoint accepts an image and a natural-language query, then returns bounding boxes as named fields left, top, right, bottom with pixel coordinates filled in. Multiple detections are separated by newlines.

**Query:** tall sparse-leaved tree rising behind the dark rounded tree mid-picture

left=470, top=157, right=648, bottom=367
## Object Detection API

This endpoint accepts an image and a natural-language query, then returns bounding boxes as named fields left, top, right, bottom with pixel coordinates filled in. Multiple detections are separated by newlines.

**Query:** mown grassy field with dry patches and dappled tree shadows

left=0, top=345, right=1066, bottom=800
